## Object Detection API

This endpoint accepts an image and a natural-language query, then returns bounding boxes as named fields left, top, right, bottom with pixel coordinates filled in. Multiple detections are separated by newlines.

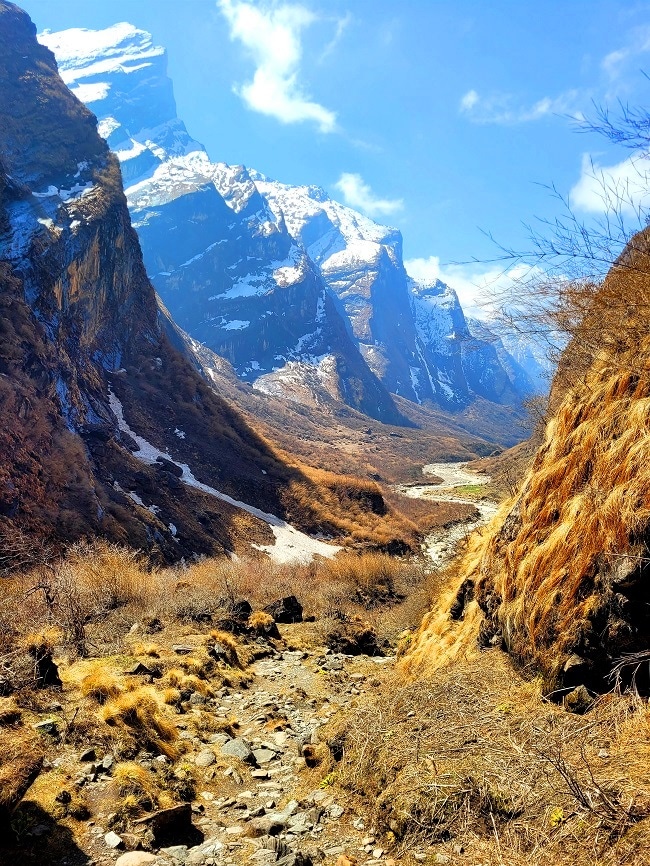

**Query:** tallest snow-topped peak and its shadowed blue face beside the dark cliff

left=41, top=24, right=400, bottom=421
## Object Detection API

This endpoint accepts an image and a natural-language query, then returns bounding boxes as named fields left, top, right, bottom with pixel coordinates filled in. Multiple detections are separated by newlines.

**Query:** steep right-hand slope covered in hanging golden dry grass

left=410, top=230, right=650, bottom=703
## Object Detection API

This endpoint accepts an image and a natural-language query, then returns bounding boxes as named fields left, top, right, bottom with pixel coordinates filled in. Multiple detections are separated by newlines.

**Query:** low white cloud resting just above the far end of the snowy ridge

left=404, top=256, right=537, bottom=319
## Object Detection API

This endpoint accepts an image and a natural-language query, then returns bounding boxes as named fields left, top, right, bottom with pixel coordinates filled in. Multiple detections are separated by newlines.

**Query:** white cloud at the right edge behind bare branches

left=570, top=153, right=650, bottom=217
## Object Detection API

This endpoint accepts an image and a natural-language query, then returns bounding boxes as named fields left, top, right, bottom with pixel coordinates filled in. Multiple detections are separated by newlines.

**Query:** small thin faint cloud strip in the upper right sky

left=459, top=90, right=582, bottom=125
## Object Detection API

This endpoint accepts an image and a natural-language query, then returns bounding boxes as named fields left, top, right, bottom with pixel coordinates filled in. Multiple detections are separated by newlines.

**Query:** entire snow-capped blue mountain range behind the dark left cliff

left=40, top=24, right=534, bottom=421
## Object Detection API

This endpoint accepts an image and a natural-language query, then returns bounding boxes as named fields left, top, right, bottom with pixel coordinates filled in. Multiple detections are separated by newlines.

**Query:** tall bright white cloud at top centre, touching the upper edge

left=217, top=0, right=336, bottom=132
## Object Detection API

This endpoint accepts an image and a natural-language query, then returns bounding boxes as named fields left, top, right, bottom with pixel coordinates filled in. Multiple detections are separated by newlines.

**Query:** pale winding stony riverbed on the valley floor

left=396, top=463, right=498, bottom=568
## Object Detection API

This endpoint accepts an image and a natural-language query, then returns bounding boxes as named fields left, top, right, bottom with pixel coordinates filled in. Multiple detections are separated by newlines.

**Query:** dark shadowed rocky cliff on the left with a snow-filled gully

left=0, top=2, right=350, bottom=560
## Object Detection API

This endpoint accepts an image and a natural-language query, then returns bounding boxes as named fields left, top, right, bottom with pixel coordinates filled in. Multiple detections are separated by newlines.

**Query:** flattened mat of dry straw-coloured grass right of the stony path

left=329, top=650, right=650, bottom=866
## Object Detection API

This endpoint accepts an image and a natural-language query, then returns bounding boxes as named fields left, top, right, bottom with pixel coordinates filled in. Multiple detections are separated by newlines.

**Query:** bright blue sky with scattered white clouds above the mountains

left=19, top=0, right=650, bottom=299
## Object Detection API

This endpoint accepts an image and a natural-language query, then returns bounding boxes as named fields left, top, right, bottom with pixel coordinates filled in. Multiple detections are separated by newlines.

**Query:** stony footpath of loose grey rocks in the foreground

left=67, top=625, right=401, bottom=866
